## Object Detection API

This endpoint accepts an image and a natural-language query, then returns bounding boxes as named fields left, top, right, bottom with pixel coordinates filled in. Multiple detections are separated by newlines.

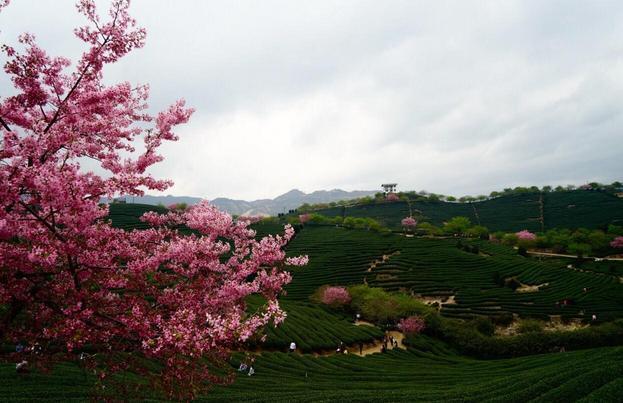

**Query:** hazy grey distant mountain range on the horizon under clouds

left=111, top=189, right=377, bottom=216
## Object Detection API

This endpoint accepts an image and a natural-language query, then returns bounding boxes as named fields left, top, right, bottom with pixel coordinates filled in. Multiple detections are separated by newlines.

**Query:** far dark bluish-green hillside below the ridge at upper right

left=316, top=190, right=623, bottom=231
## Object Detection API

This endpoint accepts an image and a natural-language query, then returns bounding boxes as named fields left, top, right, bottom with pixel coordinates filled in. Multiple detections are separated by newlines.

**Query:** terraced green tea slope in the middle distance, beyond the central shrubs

left=287, top=226, right=623, bottom=320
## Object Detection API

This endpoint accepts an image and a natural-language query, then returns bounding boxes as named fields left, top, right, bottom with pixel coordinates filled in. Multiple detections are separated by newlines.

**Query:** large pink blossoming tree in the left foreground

left=0, top=0, right=307, bottom=397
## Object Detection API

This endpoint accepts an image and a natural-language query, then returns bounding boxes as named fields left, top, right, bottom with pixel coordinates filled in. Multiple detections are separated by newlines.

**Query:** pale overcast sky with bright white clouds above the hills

left=0, top=0, right=623, bottom=199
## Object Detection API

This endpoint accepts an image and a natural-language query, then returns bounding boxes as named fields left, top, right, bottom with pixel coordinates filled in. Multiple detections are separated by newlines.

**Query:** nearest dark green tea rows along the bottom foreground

left=200, top=343, right=623, bottom=402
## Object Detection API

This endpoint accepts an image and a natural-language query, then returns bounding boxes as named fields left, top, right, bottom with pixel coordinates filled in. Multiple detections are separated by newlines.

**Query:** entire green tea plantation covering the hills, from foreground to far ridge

left=0, top=204, right=623, bottom=402
